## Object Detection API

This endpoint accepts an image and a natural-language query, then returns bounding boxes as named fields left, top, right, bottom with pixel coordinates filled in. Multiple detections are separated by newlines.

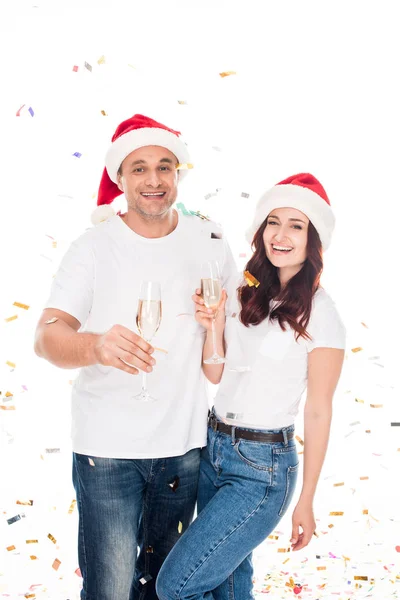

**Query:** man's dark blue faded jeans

left=73, top=448, right=200, bottom=600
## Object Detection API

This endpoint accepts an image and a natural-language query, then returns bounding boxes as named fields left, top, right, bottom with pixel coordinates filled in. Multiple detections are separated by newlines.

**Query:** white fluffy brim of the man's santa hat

left=105, top=127, right=190, bottom=183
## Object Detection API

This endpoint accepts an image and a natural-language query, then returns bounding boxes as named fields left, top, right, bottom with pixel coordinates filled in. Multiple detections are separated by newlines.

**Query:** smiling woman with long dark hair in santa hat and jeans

left=157, top=173, right=345, bottom=600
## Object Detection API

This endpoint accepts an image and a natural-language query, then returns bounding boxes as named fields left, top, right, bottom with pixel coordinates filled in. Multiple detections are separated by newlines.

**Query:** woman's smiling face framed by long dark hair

left=263, top=208, right=310, bottom=281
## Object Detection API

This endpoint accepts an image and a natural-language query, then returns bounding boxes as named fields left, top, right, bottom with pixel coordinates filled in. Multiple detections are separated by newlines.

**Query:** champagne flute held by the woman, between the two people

left=201, top=260, right=225, bottom=365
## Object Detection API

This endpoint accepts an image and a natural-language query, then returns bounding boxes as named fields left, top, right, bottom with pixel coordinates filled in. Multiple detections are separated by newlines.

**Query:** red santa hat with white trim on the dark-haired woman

left=246, top=173, right=335, bottom=250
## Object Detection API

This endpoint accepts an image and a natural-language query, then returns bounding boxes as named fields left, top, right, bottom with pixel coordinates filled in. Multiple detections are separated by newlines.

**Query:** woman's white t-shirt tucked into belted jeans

left=214, top=288, right=346, bottom=429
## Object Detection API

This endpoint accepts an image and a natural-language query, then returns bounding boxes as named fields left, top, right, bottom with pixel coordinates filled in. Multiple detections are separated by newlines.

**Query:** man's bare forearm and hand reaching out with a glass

left=34, top=308, right=155, bottom=375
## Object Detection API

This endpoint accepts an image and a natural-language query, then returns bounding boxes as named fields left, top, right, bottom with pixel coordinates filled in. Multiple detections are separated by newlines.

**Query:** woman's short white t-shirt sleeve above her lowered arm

left=306, top=295, right=346, bottom=352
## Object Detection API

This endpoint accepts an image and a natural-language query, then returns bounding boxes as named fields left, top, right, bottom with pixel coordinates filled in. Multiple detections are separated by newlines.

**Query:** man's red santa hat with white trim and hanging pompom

left=92, top=115, right=190, bottom=225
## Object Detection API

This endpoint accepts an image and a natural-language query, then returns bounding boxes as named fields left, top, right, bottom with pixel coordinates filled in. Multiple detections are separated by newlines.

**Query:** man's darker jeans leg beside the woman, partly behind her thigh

left=134, top=448, right=200, bottom=600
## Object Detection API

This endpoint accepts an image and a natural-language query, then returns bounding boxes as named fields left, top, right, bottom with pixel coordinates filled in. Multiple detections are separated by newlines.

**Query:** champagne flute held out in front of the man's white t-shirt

left=134, top=281, right=162, bottom=402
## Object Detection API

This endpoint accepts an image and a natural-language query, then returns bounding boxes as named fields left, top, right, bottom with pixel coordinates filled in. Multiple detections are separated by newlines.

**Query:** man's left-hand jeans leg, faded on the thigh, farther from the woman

left=73, top=454, right=146, bottom=600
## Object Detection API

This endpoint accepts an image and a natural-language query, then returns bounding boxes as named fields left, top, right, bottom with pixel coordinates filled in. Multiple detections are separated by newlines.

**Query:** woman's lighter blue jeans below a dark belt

left=156, top=414, right=299, bottom=600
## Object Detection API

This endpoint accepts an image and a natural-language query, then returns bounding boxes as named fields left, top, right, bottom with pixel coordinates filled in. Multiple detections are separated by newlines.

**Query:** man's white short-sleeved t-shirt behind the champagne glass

left=46, top=213, right=237, bottom=458
